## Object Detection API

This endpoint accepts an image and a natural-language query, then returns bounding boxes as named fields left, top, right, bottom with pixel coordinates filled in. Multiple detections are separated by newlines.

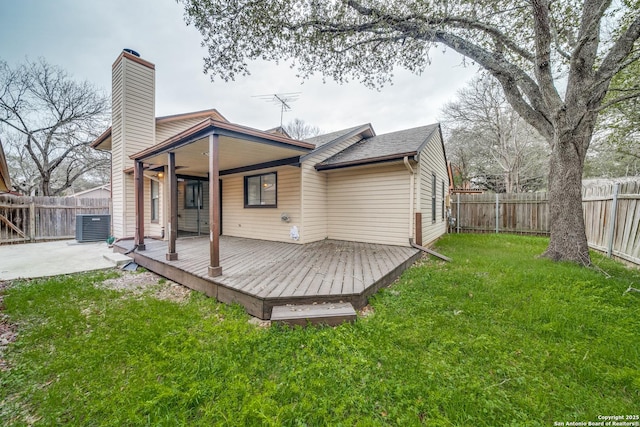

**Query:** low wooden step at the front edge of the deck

left=271, top=302, right=356, bottom=326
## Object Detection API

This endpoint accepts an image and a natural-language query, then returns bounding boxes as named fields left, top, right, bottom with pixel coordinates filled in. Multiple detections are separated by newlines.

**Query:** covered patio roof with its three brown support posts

left=130, top=118, right=315, bottom=277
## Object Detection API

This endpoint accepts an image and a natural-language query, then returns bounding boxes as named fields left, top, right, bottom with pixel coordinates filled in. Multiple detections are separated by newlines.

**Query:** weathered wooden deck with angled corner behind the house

left=116, top=236, right=420, bottom=319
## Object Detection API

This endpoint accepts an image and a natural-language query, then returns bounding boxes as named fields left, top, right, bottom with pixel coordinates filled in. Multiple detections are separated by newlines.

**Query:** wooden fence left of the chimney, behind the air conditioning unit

left=0, top=195, right=110, bottom=244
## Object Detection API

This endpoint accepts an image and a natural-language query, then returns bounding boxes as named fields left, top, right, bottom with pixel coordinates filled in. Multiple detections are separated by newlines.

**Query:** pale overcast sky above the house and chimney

left=0, top=0, right=477, bottom=134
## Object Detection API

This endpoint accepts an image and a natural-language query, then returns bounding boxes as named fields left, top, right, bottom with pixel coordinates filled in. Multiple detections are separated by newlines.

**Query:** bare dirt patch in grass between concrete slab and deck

left=96, top=271, right=193, bottom=304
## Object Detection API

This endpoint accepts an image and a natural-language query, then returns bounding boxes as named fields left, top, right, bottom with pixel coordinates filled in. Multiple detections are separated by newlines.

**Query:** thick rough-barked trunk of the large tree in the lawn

left=544, top=133, right=591, bottom=266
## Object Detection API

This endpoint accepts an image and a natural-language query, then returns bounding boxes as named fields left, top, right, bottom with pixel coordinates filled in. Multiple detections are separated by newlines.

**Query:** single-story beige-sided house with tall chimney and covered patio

left=92, top=50, right=449, bottom=317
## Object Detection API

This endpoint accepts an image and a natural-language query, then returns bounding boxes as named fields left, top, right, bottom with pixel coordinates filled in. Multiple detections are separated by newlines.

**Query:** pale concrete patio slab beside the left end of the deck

left=0, top=240, right=128, bottom=280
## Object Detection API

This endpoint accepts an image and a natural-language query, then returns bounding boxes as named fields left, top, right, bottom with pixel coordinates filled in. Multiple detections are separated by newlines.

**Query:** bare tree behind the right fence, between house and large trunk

left=442, top=75, right=549, bottom=193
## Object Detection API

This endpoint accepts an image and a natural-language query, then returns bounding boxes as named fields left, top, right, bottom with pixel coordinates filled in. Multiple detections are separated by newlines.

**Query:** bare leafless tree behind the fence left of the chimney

left=0, top=59, right=110, bottom=196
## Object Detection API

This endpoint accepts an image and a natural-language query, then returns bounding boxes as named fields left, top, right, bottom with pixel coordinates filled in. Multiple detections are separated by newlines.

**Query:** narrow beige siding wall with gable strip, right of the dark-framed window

left=301, top=135, right=362, bottom=243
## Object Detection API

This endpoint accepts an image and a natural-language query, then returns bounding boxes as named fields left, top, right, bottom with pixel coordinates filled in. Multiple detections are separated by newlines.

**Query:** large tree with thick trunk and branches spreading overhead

left=179, top=0, right=640, bottom=265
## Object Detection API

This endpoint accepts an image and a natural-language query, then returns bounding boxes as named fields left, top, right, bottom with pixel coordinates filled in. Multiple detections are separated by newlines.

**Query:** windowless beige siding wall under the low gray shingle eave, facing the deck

left=327, top=163, right=409, bottom=246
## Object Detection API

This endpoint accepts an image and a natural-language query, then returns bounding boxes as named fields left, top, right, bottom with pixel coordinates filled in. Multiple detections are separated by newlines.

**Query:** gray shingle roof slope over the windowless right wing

left=316, top=123, right=439, bottom=169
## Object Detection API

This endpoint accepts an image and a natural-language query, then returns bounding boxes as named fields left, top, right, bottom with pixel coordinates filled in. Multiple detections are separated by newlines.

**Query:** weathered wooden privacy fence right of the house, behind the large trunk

left=450, top=180, right=640, bottom=264
